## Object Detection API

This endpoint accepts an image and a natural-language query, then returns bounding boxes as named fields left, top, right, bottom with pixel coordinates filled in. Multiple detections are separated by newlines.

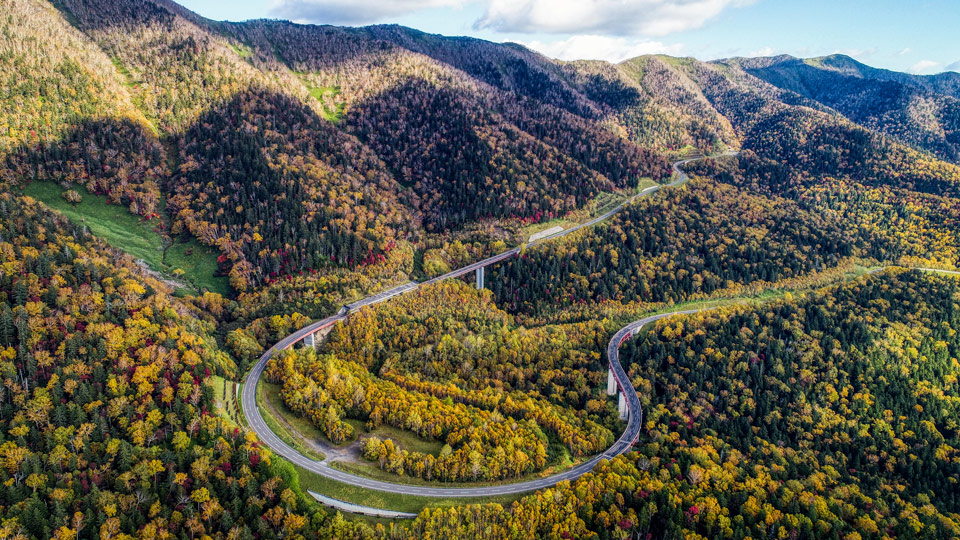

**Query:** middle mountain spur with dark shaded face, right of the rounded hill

left=224, top=21, right=669, bottom=230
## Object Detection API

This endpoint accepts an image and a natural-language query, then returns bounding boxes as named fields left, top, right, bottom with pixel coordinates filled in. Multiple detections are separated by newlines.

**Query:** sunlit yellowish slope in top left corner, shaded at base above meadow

left=0, top=0, right=166, bottom=214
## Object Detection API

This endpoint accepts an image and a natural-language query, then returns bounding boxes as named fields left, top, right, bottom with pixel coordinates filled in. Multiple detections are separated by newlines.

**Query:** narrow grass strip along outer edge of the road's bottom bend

left=290, top=457, right=522, bottom=512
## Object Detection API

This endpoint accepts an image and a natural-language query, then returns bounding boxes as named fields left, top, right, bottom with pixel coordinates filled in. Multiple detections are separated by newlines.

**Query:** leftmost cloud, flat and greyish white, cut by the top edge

left=269, top=0, right=464, bottom=25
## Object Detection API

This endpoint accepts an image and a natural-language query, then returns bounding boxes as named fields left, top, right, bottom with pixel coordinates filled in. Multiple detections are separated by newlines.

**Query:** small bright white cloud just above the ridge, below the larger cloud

left=522, top=34, right=683, bottom=62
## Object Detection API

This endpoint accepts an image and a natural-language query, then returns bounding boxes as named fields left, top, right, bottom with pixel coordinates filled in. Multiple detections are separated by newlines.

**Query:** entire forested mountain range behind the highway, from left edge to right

left=4, top=0, right=956, bottom=298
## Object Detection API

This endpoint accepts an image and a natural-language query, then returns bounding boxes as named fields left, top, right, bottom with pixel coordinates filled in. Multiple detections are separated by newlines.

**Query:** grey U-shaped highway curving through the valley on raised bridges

left=240, top=152, right=736, bottom=498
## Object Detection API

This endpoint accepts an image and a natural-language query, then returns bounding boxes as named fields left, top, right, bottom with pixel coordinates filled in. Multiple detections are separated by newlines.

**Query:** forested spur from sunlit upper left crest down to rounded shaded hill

left=49, top=0, right=416, bottom=291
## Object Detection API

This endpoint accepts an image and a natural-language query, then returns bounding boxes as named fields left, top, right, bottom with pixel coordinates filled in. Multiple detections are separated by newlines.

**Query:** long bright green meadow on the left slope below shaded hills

left=23, top=182, right=230, bottom=294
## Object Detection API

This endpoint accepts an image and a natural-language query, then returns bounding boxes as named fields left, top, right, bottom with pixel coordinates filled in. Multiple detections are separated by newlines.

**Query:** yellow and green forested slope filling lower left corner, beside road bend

left=0, top=193, right=344, bottom=539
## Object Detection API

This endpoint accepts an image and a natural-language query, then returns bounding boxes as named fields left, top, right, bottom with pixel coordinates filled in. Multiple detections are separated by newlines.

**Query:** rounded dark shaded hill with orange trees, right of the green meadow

left=169, top=90, right=414, bottom=290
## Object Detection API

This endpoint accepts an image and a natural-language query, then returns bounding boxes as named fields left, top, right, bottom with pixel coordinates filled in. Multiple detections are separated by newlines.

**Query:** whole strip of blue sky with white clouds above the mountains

left=178, top=0, right=960, bottom=74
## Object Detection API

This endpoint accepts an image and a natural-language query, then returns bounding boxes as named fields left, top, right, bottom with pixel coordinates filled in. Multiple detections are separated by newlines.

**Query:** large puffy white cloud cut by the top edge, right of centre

left=474, top=0, right=753, bottom=36
